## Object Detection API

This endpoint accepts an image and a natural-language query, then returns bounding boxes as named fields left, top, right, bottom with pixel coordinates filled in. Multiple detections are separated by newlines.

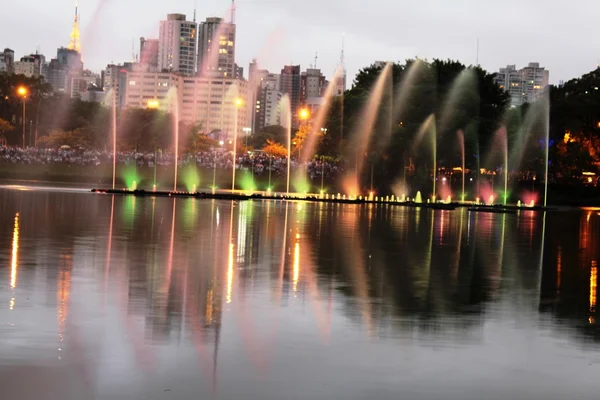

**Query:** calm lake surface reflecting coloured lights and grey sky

left=0, top=188, right=600, bottom=400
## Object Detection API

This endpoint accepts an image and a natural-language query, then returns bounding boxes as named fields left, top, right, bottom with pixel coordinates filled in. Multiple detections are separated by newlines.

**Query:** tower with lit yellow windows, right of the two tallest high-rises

left=198, top=17, right=236, bottom=78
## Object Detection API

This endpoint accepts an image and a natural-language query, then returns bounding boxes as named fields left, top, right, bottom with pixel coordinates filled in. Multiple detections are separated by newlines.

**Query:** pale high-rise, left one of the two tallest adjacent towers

left=158, top=14, right=197, bottom=76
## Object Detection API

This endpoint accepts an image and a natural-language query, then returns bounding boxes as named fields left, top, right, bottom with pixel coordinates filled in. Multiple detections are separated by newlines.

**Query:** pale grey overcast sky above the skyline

left=0, top=0, right=600, bottom=85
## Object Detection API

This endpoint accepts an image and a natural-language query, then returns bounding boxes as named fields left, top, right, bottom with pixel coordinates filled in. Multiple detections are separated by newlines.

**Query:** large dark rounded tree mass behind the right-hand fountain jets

left=318, top=60, right=510, bottom=191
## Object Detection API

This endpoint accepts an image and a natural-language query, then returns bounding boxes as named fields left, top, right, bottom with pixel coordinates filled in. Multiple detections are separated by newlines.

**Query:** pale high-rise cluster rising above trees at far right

left=494, top=63, right=550, bottom=107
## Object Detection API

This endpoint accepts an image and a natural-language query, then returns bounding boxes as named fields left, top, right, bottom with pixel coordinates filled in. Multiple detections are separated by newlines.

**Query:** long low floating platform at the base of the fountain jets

left=92, top=189, right=548, bottom=213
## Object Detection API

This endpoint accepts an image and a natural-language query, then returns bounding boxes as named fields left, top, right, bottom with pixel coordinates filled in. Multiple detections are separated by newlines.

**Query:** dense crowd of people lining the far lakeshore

left=0, top=146, right=343, bottom=179
